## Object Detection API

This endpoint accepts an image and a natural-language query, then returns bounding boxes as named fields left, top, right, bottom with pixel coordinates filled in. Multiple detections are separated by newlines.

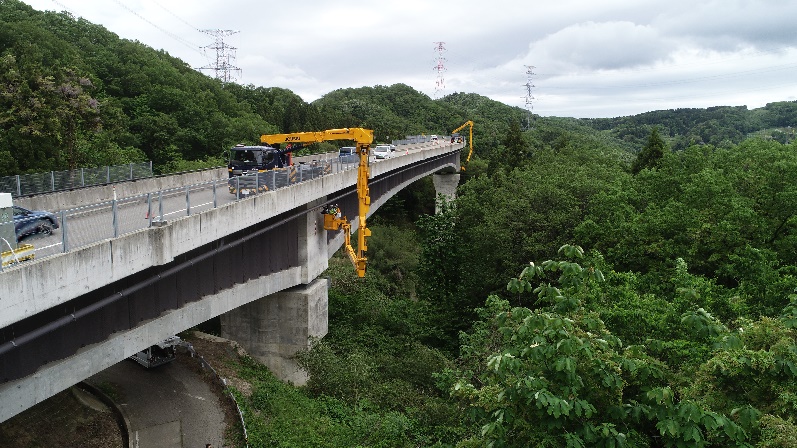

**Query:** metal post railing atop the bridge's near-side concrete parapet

left=0, top=158, right=358, bottom=272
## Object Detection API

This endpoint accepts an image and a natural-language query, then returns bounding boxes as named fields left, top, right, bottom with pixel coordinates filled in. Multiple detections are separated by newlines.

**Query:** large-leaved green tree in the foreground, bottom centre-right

left=440, top=246, right=750, bottom=447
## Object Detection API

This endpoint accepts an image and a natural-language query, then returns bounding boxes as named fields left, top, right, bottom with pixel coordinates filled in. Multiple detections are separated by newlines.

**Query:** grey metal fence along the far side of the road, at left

left=0, top=161, right=152, bottom=197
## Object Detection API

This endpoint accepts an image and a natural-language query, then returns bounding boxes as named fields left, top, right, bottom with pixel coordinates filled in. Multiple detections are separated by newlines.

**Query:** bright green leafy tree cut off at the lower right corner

left=682, top=294, right=797, bottom=447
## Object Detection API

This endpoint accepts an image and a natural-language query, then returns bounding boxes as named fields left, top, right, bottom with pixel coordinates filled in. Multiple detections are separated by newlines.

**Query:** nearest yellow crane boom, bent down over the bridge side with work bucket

left=260, top=128, right=374, bottom=277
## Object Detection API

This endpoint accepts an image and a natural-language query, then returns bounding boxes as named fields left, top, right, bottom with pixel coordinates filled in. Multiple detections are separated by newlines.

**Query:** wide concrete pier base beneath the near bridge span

left=221, top=278, right=329, bottom=386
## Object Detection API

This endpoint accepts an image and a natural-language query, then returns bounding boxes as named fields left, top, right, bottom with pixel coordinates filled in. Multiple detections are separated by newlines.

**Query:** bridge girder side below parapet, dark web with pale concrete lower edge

left=0, top=152, right=459, bottom=421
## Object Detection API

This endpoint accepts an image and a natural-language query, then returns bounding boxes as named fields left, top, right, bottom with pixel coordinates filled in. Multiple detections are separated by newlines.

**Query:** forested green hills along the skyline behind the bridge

left=0, top=0, right=797, bottom=176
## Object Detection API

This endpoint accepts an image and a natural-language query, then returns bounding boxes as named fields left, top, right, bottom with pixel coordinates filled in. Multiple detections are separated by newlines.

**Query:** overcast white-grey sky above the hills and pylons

left=23, top=0, right=797, bottom=117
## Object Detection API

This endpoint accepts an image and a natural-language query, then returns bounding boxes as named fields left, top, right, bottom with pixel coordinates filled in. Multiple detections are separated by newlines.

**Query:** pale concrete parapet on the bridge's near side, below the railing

left=0, top=171, right=348, bottom=328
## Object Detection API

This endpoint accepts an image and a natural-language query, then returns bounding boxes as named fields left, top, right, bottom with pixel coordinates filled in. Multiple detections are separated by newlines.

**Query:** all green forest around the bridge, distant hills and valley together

left=0, top=0, right=797, bottom=448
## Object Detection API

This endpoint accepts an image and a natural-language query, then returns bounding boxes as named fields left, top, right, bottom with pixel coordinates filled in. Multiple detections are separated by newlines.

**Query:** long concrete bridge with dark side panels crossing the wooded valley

left=0, top=143, right=463, bottom=422
